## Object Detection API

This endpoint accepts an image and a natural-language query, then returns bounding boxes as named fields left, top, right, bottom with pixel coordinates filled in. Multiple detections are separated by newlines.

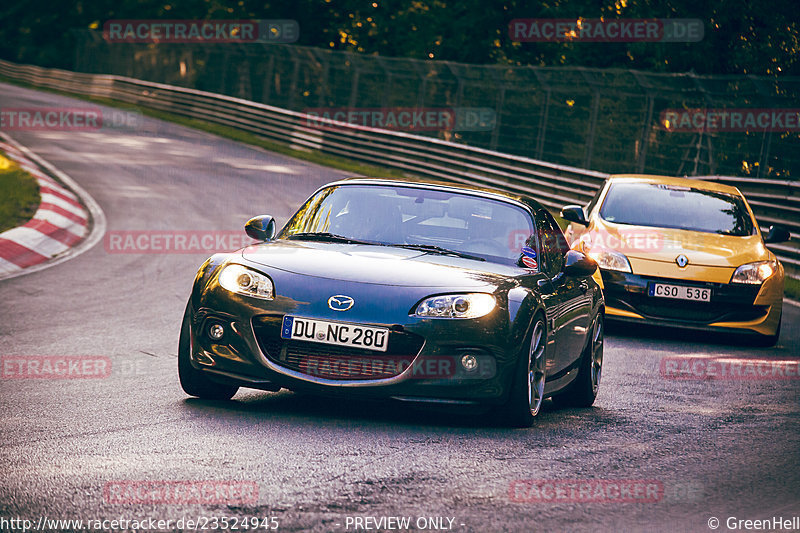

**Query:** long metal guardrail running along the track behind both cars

left=0, top=60, right=800, bottom=276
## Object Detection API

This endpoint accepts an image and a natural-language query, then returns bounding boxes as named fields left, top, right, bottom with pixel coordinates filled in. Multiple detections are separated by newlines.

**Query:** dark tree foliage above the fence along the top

left=0, top=0, right=800, bottom=75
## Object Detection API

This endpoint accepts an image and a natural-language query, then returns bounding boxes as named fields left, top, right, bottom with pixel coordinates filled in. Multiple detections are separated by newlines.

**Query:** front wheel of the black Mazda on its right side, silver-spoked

left=502, top=315, right=547, bottom=428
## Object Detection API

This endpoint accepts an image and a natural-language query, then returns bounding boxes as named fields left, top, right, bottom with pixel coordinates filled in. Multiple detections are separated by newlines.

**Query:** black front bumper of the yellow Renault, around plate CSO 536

left=602, top=270, right=782, bottom=335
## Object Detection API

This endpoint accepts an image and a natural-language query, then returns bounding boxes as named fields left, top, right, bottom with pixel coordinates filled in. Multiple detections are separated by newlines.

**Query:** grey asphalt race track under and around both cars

left=0, top=80, right=800, bottom=531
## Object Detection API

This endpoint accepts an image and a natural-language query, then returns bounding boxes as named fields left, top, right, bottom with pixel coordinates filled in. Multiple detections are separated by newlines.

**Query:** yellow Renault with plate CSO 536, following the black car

left=561, top=175, right=789, bottom=346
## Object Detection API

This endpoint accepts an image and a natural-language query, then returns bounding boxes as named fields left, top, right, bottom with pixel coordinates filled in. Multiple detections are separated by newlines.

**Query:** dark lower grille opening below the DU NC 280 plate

left=253, top=316, right=424, bottom=380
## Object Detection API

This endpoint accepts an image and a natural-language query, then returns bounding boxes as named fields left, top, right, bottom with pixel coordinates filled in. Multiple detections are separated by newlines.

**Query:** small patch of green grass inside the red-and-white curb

left=0, top=152, right=41, bottom=232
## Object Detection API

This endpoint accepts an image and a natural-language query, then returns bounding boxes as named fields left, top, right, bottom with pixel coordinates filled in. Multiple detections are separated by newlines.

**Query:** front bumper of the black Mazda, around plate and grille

left=191, top=290, right=524, bottom=404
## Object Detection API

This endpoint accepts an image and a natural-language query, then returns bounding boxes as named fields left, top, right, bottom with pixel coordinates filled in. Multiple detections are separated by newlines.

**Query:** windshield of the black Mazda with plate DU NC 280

left=278, top=185, right=532, bottom=263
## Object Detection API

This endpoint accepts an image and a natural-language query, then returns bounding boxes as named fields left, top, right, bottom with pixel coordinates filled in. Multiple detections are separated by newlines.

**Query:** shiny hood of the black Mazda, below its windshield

left=242, top=239, right=524, bottom=286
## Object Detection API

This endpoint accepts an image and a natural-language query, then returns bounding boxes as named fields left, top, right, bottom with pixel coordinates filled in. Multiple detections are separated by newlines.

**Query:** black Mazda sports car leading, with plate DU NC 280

left=178, top=179, right=604, bottom=426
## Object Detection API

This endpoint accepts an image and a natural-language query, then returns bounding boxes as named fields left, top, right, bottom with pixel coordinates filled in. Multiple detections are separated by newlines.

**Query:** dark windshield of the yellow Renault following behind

left=600, top=183, right=755, bottom=236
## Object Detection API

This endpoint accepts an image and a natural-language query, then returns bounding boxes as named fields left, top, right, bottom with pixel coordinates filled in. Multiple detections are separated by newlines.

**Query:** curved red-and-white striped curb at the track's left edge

left=0, top=135, right=105, bottom=279
